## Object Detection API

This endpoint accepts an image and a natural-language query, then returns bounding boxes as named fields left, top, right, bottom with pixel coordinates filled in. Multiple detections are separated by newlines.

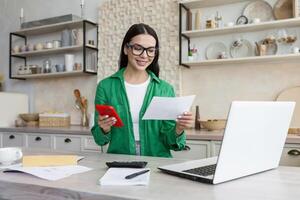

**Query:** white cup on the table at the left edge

left=0, top=147, right=23, bottom=165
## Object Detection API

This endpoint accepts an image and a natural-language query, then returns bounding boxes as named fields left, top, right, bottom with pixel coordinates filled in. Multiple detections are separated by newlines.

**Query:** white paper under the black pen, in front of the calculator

left=99, top=168, right=150, bottom=185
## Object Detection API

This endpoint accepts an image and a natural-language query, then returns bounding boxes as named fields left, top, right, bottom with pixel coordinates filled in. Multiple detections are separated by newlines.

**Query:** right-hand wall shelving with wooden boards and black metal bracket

left=179, top=0, right=300, bottom=68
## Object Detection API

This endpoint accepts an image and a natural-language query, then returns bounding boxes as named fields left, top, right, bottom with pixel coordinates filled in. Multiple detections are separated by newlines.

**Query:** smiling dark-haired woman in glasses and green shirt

left=92, top=24, right=193, bottom=157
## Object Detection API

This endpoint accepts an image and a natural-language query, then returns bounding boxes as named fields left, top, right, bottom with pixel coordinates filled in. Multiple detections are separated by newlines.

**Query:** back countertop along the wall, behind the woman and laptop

left=0, top=126, right=300, bottom=144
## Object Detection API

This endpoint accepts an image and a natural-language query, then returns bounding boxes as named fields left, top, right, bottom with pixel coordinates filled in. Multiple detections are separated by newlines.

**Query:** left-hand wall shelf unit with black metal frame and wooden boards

left=9, top=20, right=98, bottom=79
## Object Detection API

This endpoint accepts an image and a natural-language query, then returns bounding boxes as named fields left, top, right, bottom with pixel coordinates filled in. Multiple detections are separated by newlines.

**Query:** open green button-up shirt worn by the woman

left=91, top=68, right=186, bottom=157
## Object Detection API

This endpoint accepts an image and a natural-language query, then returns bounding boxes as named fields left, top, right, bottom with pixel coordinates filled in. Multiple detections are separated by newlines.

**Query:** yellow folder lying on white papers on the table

left=22, top=155, right=78, bottom=167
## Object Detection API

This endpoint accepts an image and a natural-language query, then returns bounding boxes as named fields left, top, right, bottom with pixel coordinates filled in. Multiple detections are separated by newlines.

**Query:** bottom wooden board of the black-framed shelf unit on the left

left=12, top=70, right=97, bottom=79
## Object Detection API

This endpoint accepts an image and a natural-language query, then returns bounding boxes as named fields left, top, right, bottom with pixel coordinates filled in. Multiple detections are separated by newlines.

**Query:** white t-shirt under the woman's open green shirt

left=125, top=76, right=150, bottom=141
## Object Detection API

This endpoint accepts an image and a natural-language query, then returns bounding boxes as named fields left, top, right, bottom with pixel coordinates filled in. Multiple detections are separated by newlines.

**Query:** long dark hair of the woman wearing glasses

left=119, top=23, right=159, bottom=77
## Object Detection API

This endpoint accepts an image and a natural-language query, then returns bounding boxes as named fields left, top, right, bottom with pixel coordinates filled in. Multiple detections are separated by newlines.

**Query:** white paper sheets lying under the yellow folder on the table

left=5, top=165, right=92, bottom=181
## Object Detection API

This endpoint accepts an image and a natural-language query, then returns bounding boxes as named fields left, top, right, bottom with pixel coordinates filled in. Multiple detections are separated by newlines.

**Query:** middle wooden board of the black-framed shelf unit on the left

left=11, top=45, right=83, bottom=57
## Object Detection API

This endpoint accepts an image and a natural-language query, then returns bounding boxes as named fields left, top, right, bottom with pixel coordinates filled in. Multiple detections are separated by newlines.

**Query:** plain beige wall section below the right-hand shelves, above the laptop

left=182, top=62, right=300, bottom=119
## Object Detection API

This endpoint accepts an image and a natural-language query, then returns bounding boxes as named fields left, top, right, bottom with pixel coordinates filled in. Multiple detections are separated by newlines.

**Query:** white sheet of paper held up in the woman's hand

left=142, top=95, right=195, bottom=120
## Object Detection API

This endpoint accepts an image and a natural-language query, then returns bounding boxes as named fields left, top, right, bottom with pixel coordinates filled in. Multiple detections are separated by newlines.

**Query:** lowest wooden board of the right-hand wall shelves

left=182, top=53, right=300, bottom=67
